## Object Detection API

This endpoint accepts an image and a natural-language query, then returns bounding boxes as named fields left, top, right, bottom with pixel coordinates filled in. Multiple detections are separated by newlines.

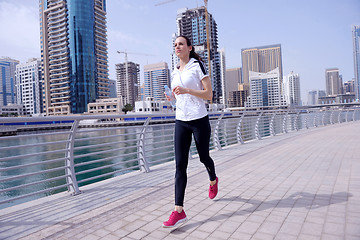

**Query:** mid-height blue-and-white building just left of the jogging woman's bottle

left=144, top=62, right=170, bottom=100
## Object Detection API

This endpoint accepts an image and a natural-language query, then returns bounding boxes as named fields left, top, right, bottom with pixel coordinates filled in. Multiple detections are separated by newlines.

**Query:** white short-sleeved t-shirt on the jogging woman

left=171, top=58, right=208, bottom=121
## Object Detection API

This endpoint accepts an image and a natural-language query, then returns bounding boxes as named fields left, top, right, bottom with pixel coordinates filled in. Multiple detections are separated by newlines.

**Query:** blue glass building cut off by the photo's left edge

left=0, top=57, right=19, bottom=106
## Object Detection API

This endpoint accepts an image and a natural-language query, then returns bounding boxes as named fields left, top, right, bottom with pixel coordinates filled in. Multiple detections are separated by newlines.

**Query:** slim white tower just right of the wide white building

left=283, top=72, right=301, bottom=106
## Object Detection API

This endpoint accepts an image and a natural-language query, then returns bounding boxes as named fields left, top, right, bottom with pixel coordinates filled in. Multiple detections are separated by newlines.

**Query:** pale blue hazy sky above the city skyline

left=0, top=0, right=360, bottom=102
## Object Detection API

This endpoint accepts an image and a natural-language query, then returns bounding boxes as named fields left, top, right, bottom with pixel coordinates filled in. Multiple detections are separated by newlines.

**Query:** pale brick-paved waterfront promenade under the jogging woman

left=0, top=122, right=360, bottom=240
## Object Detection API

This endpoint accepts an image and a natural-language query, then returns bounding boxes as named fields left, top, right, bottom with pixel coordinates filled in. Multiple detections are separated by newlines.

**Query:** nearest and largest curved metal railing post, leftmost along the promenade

left=65, top=120, right=81, bottom=195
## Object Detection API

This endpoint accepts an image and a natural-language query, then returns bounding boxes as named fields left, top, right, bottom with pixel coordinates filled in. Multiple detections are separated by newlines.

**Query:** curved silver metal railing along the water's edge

left=0, top=108, right=360, bottom=207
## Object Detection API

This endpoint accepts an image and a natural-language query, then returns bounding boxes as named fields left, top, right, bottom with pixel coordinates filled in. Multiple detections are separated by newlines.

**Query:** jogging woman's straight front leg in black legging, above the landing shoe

left=174, top=120, right=192, bottom=206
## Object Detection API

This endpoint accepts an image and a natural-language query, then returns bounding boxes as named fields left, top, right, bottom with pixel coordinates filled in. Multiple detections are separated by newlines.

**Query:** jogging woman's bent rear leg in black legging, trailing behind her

left=192, top=116, right=216, bottom=181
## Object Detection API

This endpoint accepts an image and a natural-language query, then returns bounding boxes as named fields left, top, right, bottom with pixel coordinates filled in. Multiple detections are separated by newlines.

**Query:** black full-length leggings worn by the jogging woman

left=175, top=116, right=216, bottom=206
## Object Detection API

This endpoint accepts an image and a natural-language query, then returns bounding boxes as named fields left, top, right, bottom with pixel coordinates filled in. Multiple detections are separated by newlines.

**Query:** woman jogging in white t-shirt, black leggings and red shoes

left=163, top=36, right=219, bottom=228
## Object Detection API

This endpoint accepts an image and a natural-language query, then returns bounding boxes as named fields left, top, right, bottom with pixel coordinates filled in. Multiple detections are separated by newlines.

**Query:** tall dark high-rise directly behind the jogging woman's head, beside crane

left=174, top=7, right=222, bottom=103
